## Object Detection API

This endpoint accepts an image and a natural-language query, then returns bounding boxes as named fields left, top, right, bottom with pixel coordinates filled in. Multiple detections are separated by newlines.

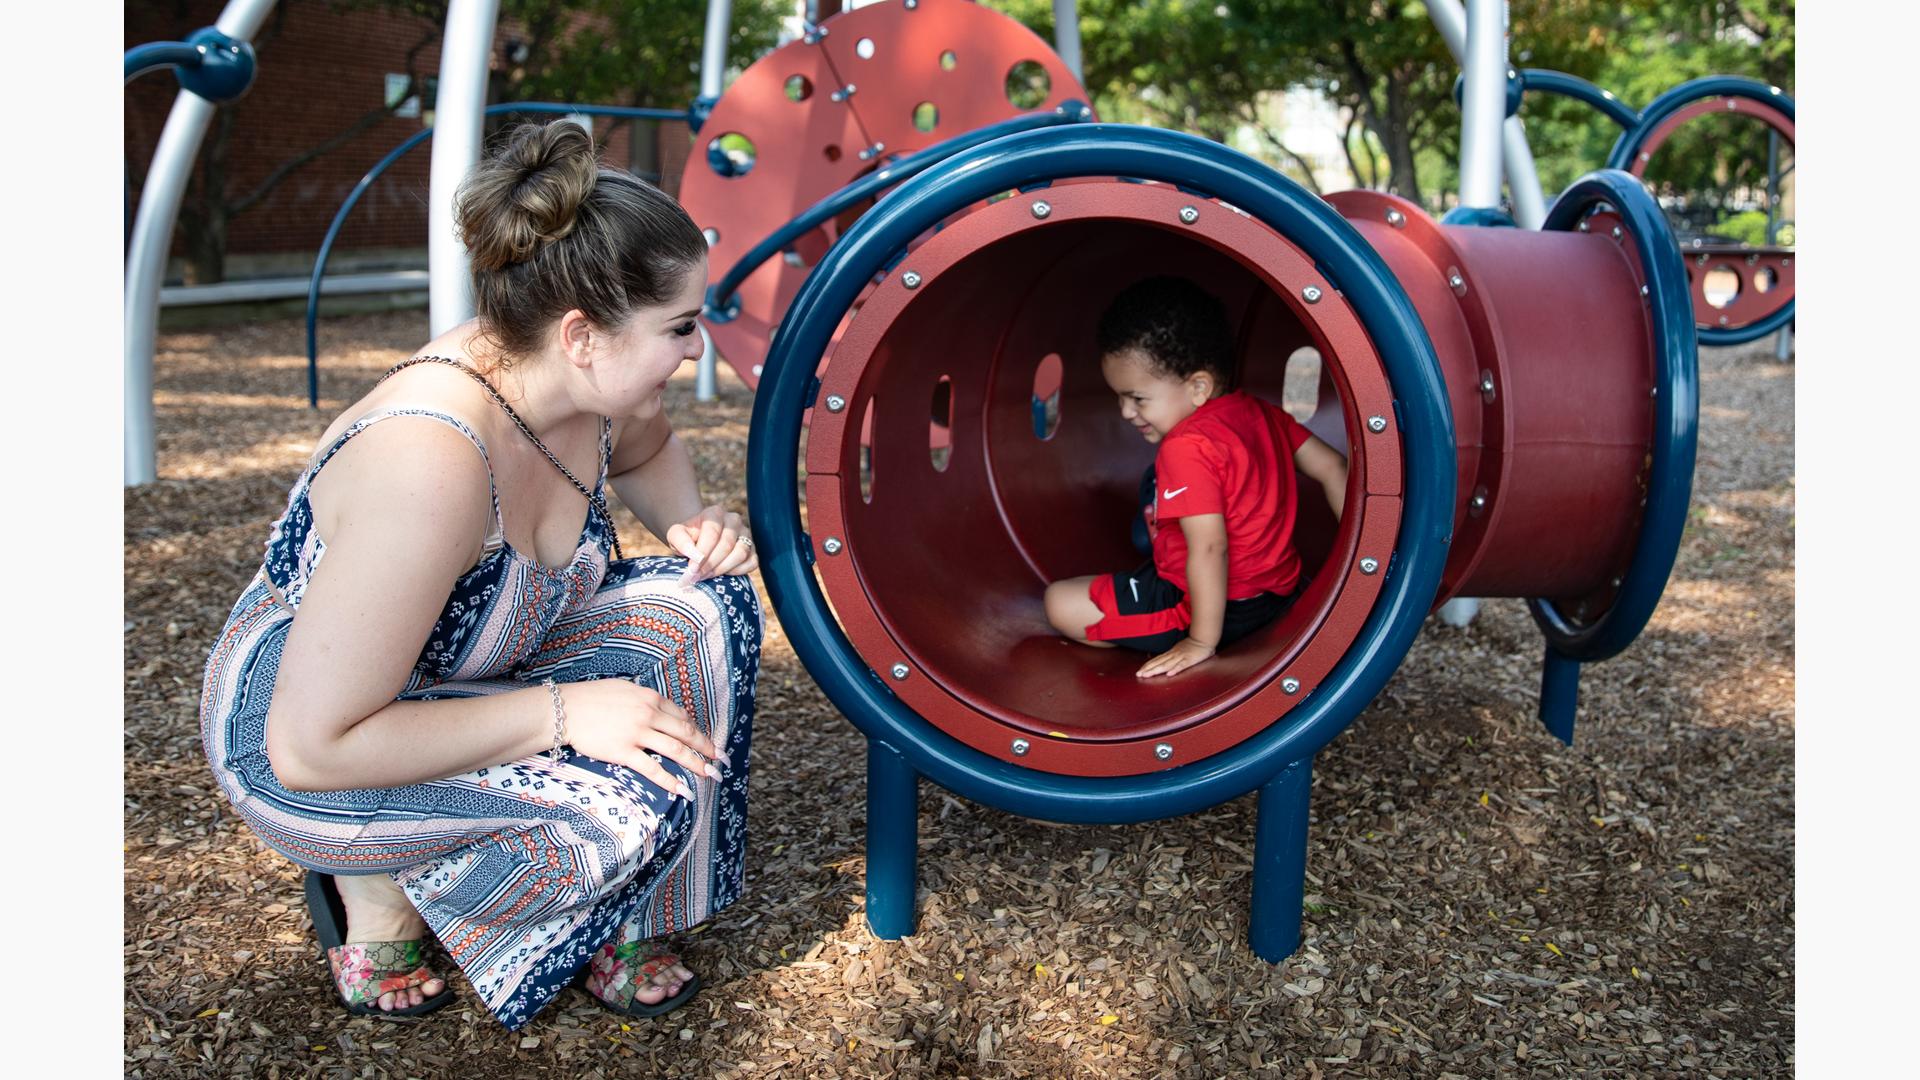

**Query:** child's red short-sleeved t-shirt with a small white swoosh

left=1146, top=390, right=1311, bottom=600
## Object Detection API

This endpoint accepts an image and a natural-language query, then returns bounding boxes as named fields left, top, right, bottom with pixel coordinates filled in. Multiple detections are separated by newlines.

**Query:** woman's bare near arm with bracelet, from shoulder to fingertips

left=267, top=417, right=712, bottom=792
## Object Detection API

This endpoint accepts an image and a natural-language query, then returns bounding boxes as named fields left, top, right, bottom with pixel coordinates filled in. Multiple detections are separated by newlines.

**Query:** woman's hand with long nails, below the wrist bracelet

left=559, top=678, right=732, bottom=801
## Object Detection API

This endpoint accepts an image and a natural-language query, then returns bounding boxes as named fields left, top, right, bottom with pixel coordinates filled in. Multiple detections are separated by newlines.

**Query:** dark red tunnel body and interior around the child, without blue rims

left=806, top=181, right=1651, bottom=774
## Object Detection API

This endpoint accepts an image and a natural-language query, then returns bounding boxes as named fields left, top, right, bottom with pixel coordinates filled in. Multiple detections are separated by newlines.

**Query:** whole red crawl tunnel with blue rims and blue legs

left=716, top=6, right=1697, bottom=959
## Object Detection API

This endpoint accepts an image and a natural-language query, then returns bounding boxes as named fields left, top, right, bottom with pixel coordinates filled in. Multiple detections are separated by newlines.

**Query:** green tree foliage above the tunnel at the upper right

left=993, top=0, right=1793, bottom=208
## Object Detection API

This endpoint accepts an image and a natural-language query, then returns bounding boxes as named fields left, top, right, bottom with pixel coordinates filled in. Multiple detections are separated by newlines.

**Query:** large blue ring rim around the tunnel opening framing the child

left=747, top=123, right=1455, bottom=824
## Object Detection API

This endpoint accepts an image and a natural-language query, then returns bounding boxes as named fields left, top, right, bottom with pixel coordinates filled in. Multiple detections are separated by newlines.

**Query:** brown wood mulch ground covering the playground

left=125, top=313, right=1793, bottom=1078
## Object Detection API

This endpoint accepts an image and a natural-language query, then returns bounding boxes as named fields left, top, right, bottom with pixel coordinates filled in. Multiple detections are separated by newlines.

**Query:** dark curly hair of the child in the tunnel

left=1096, top=277, right=1233, bottom=386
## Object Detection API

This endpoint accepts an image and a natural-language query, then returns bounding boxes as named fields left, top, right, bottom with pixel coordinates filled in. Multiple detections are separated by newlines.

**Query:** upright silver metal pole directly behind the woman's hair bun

left=426, top=0, right=499, bottom=336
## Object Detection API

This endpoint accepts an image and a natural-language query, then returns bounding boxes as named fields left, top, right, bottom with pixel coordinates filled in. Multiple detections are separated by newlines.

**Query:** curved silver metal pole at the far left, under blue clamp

left=121, top=0, right=275, bottom=488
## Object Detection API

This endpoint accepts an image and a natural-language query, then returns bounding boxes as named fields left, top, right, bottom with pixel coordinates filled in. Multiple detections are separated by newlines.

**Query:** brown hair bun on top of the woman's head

left=453, top=121, right=599, bottom=271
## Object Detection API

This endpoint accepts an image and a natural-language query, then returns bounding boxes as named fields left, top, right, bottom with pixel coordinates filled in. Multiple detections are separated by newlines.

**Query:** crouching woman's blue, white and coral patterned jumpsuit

left=200, top=409, right=764, bottom=1028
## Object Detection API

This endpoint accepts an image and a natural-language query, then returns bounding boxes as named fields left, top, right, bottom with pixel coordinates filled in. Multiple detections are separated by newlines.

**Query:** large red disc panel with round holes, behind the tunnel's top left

left=680, top=0, right=1092, bottom=386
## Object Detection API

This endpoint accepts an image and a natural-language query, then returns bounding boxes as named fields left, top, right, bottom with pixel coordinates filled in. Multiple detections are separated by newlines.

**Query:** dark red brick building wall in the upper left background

left=125, top=0, right=689, bottom=281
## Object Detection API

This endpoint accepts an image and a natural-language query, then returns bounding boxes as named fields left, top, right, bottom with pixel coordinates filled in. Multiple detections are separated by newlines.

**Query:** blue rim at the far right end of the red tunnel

left=1526, top=169, right=1699, bottom=661
